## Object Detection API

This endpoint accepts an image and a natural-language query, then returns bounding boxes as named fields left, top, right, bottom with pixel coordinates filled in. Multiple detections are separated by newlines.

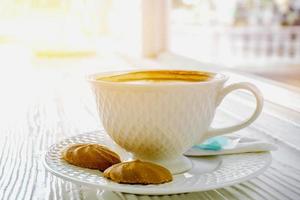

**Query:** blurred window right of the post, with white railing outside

left=170, top=0, right=300, bottom=66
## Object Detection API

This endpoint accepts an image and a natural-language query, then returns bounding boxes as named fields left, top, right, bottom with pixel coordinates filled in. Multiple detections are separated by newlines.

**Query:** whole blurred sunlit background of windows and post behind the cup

left=0, top=0, right=300, bottom=87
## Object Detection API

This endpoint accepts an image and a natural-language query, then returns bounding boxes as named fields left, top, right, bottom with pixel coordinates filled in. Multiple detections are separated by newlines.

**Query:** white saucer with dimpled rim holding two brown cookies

left=44, top=131, right=272, bottom=195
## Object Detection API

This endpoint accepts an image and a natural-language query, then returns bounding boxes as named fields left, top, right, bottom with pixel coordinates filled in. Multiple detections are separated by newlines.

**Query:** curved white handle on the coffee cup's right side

left=207, top=82, right=264, bottom=137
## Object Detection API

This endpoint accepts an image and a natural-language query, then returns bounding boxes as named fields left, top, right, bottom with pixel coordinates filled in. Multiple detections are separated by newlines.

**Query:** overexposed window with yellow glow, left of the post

left=0, top=0, right=141, bottom=57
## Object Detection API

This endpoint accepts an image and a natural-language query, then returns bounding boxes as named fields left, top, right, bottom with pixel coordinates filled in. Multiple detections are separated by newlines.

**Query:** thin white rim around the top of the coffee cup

left=86, top=68, right=229, bottom=87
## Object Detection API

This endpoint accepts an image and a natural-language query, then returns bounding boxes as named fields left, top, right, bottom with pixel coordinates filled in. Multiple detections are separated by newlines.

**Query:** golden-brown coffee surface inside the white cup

left=96, top=70, right=215, bottom=83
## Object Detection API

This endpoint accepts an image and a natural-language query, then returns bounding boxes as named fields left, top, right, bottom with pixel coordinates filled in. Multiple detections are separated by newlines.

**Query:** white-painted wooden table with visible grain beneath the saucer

left=0, top=55, right=300, bottom=200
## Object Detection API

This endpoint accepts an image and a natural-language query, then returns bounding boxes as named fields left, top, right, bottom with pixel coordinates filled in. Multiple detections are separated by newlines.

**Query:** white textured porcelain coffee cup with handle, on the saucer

left=88, top=71, right=263, bottom=174
